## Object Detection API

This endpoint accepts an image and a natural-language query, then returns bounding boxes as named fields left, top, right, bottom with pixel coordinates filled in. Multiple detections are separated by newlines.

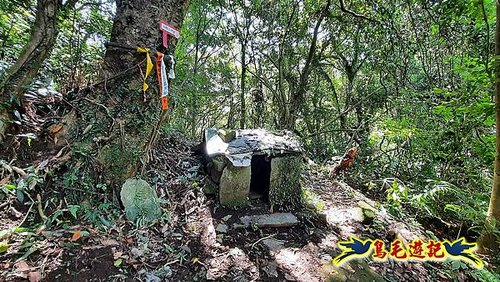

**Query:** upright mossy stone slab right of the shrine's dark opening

left=269, top=156, right=303, bottom=207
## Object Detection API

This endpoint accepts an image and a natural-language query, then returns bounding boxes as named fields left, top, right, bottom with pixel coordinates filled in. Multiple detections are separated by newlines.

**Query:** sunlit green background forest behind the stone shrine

left=0, top=0, right=498, bottom=280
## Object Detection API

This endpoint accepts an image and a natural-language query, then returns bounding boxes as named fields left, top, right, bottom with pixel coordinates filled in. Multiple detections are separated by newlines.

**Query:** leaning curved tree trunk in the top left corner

left=0, top=0, right=60, bottom=142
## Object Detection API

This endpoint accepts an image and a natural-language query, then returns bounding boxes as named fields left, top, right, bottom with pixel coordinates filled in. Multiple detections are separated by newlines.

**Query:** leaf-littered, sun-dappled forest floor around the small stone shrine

left=0, top=133, right=492, bottom=281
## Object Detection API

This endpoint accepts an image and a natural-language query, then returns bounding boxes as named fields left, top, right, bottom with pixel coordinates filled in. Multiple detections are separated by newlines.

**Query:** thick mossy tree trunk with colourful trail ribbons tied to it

left=65, top=0, right=189, bottom=186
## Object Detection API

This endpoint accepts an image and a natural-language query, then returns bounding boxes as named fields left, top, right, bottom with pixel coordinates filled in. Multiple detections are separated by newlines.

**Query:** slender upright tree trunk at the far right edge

left=479, top=0, right=500, bottom=253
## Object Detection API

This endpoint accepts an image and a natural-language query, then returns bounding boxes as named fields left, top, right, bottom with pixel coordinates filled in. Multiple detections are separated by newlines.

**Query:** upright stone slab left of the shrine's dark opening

left=219, top=165, right=251, bottom=207
